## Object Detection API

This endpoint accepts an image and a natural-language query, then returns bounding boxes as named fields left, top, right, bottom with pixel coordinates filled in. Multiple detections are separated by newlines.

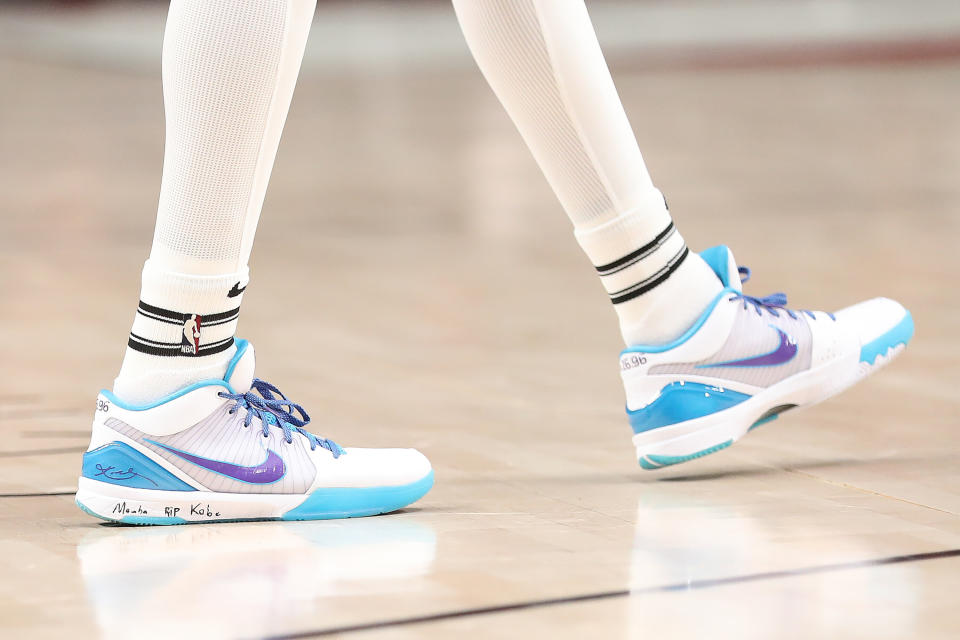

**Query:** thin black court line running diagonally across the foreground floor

left=264, top=549, right=960, bottom=640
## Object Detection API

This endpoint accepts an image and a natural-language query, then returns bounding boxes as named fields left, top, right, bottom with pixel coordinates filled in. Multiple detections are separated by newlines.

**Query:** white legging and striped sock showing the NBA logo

left=114, top=0, right=316, bottom=404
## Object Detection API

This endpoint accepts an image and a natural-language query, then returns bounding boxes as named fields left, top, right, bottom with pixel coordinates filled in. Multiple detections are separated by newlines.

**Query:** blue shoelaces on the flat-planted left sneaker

left=217, top=378, right=346, bottom=458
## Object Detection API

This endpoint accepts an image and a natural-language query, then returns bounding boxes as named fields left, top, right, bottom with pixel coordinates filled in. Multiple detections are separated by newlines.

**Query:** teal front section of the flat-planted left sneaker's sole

left=280, top=471, right=433, bottom=520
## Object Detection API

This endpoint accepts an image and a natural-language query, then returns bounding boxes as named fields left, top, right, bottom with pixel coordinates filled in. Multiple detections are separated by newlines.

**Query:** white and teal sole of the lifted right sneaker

left=633, top=312, right=913, bottom=470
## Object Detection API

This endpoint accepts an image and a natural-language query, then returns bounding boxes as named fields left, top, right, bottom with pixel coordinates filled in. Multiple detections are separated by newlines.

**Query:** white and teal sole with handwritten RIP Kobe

left=76, top=471, right=433, bottom=525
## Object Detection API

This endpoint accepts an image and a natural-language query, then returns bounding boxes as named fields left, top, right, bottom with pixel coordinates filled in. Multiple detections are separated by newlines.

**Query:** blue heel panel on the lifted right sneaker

left=627, top=382, right=750, bottom=433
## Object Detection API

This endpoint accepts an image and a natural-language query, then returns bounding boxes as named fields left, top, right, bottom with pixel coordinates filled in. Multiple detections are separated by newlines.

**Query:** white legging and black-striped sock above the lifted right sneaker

left=453, top=0, right=721, bottom=345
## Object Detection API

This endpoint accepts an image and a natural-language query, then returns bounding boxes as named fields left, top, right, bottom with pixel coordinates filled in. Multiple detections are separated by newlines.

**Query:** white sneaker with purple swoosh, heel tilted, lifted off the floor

left=620, top=246, right=913, bottom=469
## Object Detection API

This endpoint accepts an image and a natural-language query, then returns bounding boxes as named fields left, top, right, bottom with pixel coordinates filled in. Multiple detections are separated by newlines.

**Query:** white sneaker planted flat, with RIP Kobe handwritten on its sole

left=77, top=340, right=433, bottom=524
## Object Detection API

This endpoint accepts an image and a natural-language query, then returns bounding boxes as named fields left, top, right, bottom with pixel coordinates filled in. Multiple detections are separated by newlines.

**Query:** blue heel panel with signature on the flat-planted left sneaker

left=81, top=442, right=196, bottom=491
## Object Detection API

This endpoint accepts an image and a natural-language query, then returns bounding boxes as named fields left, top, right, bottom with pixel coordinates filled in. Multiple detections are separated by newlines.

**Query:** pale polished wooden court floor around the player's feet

left=0, top=45, right=960, bottom=640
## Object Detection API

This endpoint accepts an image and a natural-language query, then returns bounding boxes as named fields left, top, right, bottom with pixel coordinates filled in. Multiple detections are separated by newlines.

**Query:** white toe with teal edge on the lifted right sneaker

left=834, top=298, right=913, bottom=362
